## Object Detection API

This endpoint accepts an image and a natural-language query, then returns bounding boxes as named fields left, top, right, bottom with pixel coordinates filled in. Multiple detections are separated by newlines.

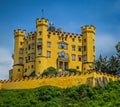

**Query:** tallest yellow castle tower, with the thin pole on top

left=35, top=18, right=48, bottom=74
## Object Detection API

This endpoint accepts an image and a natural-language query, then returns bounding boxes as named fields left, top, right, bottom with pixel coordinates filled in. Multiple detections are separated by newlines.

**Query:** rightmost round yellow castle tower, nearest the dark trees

left=81, top=25, right=95, bottom=72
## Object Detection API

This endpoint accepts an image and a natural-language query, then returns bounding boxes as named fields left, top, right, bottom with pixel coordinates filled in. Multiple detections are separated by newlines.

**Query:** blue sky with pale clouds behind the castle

left=0, top=0, right=120, bottom=79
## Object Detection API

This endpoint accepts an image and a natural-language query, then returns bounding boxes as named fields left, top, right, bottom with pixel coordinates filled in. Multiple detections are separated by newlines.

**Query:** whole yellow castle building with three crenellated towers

left=10, top=18, right=95, bottom=79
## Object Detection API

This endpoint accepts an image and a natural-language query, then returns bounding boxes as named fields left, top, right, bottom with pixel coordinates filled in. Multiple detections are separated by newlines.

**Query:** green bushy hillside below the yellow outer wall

left=0, top=81, right=120, bottom=107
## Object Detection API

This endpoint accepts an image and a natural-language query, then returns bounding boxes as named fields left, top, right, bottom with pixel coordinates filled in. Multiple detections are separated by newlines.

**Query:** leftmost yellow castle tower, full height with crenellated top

left=11, top=29, right=26, bottom=79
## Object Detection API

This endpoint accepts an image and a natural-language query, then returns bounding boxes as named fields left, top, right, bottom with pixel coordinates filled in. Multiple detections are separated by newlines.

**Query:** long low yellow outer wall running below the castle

left=0, top=72, right=120, bottom=90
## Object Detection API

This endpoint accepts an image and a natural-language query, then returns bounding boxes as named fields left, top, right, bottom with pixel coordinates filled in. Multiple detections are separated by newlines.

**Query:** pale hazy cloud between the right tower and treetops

left=96, top=34, right=117, bottom=57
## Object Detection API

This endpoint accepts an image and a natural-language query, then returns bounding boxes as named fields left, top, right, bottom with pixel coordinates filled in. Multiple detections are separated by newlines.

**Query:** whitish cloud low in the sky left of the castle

left=0, top=47, right=13, bottom=80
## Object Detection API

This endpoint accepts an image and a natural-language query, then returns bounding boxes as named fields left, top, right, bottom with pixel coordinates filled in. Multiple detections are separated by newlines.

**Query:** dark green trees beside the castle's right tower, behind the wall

left=92, top=42, right=120, bottom=76
